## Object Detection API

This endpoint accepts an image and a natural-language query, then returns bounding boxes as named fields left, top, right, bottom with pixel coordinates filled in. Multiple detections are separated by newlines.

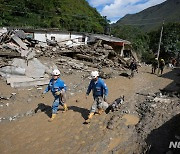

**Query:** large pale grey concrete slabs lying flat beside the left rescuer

left=0, top=58, right=56, bottom=88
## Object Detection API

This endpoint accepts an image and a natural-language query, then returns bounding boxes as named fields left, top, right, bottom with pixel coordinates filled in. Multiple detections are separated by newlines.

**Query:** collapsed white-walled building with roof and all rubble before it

left=0, top=28, right=137, bottom=87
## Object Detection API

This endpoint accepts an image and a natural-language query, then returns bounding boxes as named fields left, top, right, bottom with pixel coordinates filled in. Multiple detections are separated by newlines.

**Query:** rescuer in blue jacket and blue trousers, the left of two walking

left=43, top=69, right=68, bottom=122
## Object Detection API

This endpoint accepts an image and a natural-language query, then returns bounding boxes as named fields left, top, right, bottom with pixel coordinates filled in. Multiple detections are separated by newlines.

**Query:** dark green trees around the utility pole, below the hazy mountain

left=112, top=23, right=180, bottom=63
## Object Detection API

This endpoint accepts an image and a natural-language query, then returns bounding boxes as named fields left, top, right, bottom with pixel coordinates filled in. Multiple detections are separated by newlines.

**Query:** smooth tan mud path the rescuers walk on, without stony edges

left=0, top=66, right=176, bottom=154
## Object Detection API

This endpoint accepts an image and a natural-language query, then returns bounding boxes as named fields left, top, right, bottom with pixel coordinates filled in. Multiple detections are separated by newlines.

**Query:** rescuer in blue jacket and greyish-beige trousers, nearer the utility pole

left=86, top=71, right=108, bottom=122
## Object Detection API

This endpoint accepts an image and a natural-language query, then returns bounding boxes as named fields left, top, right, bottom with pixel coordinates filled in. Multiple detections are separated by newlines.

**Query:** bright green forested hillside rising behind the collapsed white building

left=0, top=0, right=106, bottom=33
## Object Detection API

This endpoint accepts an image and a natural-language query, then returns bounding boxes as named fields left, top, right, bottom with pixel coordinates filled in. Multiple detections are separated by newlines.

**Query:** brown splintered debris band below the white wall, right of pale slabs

left=39, top=45, right=128, bottom=70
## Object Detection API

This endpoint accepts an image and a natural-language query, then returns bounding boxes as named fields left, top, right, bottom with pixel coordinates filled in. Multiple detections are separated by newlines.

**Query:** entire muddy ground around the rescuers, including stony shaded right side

left=0, top=63, right=180, bottom=154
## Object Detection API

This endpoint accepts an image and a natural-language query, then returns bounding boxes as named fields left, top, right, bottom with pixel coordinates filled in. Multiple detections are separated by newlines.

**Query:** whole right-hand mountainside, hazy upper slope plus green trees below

left=112, top=0, right=180, bottom=62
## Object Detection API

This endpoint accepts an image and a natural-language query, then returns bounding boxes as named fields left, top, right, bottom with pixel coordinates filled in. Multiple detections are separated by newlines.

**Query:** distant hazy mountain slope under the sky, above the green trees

left=113, top=0, right=180, bottom=31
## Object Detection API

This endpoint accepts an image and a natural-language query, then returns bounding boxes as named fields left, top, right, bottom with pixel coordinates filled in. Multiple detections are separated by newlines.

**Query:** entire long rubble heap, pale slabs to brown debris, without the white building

left=0, top=28, right=128, bottom=87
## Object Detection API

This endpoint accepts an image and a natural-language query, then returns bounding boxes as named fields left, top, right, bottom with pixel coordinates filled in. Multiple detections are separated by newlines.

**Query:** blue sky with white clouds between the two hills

left=87, top=0, right=166, bottom=23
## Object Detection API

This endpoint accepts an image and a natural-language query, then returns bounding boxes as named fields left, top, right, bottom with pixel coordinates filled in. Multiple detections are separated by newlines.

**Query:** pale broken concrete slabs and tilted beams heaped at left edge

left=0, top=29, right=57, bottom=88
